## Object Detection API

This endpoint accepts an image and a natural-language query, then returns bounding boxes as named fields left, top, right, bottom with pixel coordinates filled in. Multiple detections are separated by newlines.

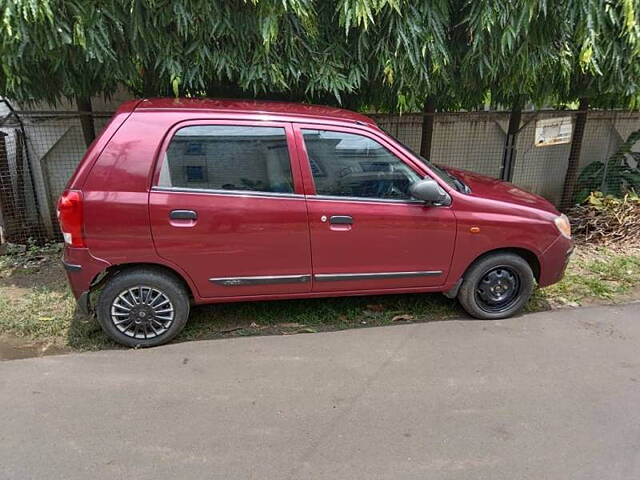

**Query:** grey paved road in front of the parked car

left=0, top=304, right=640, bottom=480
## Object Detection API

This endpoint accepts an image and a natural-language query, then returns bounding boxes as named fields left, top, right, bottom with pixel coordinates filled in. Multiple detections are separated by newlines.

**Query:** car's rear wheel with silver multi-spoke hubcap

left=96, top=268, right=189, bottom=347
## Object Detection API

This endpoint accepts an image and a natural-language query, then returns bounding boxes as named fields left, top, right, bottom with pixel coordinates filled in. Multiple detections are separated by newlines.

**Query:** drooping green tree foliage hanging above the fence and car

left=0, top=0, right=640, bottom=110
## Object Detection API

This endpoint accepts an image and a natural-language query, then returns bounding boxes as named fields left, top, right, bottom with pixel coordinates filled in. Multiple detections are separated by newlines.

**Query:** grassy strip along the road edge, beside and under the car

left=0, top=245, right=640, bottom=350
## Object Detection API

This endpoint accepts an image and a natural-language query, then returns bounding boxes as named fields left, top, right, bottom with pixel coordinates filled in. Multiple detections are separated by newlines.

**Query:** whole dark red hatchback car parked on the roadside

left=58, top=99, right=572, bottom=346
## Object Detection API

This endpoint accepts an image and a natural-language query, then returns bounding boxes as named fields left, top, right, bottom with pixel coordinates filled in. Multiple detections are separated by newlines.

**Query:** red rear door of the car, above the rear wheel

left=149, top=121, right=311, bottom=297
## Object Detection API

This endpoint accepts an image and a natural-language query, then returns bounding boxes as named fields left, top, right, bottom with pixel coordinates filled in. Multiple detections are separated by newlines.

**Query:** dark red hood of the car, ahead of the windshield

left=442, top=167, right=559, bottom=215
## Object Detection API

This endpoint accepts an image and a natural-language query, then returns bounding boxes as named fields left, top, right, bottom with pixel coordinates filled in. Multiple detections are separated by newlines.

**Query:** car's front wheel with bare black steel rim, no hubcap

left=458, top=253, right=535, bottom=320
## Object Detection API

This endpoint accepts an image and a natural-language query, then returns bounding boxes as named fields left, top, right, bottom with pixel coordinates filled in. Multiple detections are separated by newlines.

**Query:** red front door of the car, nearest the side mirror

left=294, top=124, right=456, bottom=292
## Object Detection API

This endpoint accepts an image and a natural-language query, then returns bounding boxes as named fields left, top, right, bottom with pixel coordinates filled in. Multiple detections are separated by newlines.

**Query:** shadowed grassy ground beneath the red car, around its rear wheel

left=67, top=293, right=490, bottom=350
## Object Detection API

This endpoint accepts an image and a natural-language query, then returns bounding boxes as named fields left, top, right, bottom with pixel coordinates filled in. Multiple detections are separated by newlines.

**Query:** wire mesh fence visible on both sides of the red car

left=0, top=109, right=640, bottom=243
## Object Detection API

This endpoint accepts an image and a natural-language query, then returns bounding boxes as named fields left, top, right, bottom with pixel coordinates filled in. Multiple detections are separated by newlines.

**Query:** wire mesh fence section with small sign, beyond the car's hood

left=374, top=110, right=640, bottom=210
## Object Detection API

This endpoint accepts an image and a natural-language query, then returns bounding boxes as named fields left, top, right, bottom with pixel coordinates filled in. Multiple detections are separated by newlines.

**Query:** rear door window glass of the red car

left=158, top=125, right=294, bottom=193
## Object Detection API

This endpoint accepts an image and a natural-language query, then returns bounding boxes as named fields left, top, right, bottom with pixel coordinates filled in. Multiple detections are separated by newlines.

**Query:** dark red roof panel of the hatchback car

left=135, top=98, right=376, bottom=125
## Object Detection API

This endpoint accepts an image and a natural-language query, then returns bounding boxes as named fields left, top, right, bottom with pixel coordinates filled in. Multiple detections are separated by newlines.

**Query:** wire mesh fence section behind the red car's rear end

left=0, top=100, right=111, bottom=244
